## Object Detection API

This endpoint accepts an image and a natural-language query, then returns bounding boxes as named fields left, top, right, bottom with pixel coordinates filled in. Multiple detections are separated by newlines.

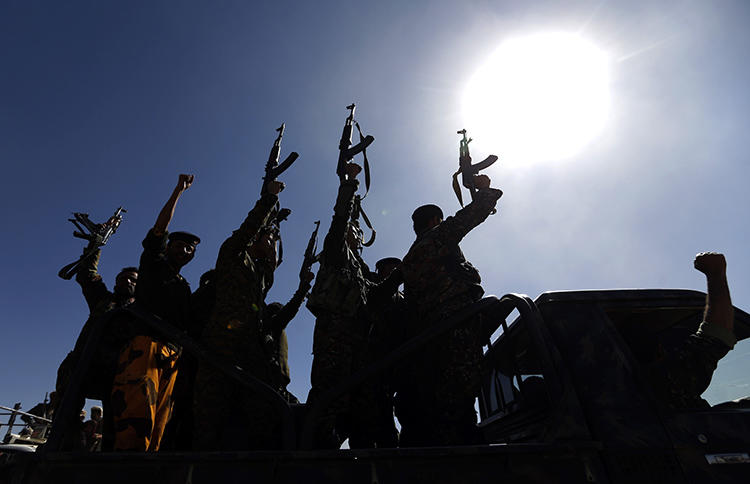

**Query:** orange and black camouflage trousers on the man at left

left=112, top=336, right=179, bottom=451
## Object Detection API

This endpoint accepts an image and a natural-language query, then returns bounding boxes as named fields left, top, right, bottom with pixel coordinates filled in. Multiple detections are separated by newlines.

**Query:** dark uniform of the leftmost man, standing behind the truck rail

left=55, top=249, right=130, bottom=449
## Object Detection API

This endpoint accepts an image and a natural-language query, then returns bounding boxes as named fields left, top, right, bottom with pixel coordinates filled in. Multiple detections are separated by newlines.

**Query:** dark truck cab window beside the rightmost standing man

left=479, top=319, right=549, bottom=420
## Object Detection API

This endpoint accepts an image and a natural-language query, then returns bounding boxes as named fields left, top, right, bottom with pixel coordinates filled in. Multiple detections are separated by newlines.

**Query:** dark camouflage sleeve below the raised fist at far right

left=645, top=321, right=737, bottom=408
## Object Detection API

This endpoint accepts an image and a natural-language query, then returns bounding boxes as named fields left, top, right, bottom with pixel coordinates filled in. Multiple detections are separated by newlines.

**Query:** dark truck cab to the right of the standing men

left=479, top=290, right=750, bottom=483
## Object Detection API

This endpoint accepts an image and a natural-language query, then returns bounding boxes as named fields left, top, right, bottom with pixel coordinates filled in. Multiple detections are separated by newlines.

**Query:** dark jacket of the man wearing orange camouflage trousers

left=135, top=229, right=190, bottom=334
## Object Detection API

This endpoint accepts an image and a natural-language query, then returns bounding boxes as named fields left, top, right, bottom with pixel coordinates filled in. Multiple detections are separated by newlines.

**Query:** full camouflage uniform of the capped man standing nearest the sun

left=396, top=188, right=502, bottom=446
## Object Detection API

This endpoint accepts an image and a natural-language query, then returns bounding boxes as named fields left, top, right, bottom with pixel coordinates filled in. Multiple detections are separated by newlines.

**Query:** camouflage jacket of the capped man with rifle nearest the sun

left=401, top=188, right=502, bottom=320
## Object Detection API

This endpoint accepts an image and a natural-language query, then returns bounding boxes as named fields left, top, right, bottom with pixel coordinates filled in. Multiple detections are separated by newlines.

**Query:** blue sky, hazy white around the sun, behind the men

left=0, top=0, right=750, bottom=416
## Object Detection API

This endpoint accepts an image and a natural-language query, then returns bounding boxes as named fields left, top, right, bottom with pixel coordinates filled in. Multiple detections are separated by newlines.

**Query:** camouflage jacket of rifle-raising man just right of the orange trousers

left=207, top=193, right=278, bottom=338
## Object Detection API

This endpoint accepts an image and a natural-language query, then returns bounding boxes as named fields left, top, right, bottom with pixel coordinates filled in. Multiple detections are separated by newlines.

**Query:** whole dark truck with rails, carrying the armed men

left=2, top=290, right=750, bottom=484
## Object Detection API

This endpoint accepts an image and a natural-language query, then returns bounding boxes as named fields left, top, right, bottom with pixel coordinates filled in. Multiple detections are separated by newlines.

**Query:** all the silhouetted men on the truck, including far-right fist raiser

left=48, top=142, right=736, bottom=451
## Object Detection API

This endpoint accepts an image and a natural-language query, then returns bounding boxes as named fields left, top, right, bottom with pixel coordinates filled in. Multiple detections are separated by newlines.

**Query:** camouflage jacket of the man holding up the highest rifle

left=307, top=180, right=372, bottom=317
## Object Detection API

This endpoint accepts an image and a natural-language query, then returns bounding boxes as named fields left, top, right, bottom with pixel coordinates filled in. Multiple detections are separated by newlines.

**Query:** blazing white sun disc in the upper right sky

left=463, top=33, right=609, bottom=164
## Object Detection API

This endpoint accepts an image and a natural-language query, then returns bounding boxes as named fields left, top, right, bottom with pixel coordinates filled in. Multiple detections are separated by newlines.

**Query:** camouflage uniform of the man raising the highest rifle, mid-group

left=307, top=179, right=372, bottom=448
